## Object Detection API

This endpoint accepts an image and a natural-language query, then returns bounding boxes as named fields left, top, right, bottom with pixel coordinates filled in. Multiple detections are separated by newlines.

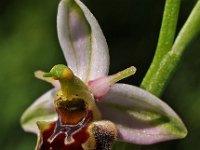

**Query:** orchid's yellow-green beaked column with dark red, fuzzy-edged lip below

left=36, top=65, right=117, bottom=150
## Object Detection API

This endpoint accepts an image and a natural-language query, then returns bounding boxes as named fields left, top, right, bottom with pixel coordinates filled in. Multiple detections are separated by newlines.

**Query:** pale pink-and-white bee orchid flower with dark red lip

left=21, top=0, right=187, bottom=150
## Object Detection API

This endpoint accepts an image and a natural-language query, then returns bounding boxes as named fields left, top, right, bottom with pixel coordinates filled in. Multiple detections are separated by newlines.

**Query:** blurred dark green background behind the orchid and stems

left=0, top=0, right=200, bottom=150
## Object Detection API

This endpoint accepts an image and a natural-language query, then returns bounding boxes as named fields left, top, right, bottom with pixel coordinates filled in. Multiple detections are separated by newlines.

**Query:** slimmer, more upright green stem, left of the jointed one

left=141, top=0, right=180, bottom=95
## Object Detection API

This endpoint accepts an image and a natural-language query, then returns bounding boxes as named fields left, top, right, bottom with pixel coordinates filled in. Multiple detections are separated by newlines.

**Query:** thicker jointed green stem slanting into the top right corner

left=142, top=0, right=200, bottom=96
